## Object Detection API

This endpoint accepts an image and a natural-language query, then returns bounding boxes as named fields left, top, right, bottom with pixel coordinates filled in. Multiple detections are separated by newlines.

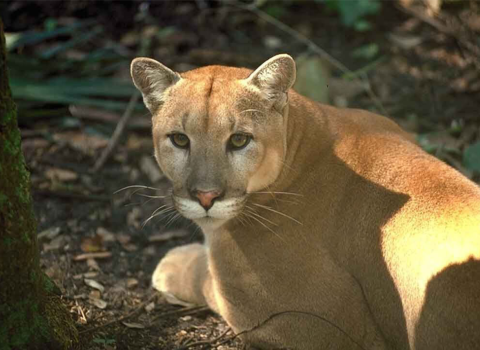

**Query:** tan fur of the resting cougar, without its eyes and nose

left=132, top=55, right=480, bottom=350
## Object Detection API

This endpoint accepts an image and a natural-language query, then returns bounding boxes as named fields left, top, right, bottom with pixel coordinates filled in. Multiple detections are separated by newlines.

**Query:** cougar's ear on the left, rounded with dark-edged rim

left=130, top=57, right=181, bottom=113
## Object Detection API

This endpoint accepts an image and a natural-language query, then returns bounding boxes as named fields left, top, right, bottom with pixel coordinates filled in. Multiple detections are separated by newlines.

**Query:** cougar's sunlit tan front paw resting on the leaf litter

left=152, top=243, right=218, bottom=312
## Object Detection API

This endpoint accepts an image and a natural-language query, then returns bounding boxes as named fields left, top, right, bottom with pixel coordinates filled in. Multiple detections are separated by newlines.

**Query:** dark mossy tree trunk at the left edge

left=0, top=19, right=78, bottom=350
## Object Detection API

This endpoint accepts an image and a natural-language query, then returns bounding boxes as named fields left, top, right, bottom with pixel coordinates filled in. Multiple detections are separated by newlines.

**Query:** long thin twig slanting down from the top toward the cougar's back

left=222, top=0, right=387, bottom=115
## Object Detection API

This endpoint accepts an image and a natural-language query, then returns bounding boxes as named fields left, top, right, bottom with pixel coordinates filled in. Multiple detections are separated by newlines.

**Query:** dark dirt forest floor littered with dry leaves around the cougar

left=5, top=0, right=480, bottom=350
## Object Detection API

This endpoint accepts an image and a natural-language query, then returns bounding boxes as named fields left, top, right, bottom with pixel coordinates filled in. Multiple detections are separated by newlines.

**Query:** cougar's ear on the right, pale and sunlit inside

left=246, top=54, right=296, bottom=110
